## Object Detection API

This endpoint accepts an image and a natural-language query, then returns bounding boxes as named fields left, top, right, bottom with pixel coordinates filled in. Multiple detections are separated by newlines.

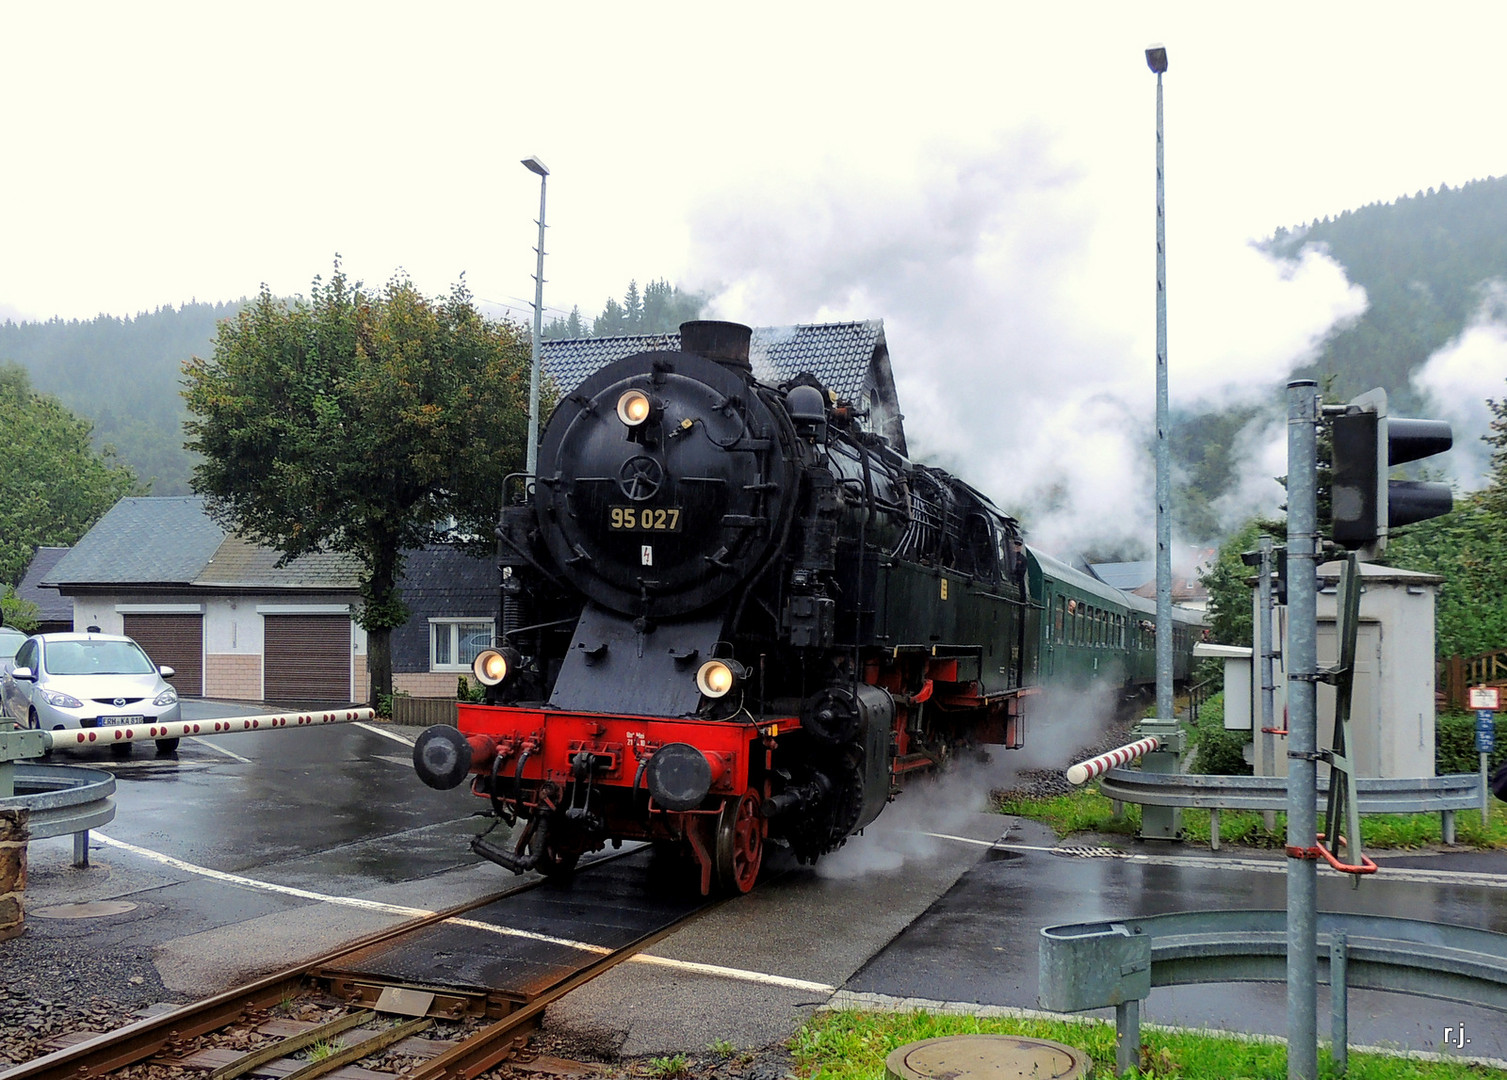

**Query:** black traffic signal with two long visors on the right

left=1329, top=390, right=1454, bottom=557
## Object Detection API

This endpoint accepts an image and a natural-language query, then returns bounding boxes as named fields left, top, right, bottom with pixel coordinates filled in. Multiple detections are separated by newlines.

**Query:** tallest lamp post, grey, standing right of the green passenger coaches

left=1145, top=45, right=1175, bottom=725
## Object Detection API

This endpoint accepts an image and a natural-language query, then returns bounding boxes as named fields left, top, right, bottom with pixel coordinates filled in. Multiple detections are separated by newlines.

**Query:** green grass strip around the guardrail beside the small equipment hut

left=995, top=783, right=1507, bottom=851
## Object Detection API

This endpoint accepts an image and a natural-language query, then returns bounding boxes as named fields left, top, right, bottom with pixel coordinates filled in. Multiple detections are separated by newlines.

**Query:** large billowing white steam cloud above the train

left=690, top=130, right=1365, bottom=553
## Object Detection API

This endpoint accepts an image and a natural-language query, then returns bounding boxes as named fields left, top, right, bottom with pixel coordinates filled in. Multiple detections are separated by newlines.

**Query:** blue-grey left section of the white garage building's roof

left=42, top=496, right=225, bottom=586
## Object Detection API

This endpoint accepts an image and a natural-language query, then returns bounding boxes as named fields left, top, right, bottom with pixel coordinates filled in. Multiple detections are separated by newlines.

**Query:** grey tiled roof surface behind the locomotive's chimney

left=540, top=319, right=885, bottom=401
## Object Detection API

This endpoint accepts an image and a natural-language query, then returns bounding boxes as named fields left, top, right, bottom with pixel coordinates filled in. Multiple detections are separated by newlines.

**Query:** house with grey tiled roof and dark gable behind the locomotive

left=540, top=319, right=907, bottom=453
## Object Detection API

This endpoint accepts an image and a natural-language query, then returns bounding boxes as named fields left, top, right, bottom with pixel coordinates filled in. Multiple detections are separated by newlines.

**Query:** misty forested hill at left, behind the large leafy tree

left=0, top=303, right=240, bottom=496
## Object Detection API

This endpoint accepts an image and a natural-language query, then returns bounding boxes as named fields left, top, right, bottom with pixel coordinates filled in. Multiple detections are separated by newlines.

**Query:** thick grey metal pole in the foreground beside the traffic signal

left=1287, top=380, right=1319, bottom=1080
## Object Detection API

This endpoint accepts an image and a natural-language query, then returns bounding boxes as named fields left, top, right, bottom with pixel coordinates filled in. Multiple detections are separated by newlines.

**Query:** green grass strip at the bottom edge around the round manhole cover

left=790, top=1011, right=1489, bottom=1080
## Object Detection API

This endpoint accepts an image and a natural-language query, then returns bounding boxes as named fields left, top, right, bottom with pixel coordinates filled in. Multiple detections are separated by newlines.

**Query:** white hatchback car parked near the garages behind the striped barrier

left=3, top=634, right=179, bottom=758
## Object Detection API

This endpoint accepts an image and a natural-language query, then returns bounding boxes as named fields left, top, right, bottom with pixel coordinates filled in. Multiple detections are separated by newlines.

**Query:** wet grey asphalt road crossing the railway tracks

left=11, top=703, right=1507, bottom=1057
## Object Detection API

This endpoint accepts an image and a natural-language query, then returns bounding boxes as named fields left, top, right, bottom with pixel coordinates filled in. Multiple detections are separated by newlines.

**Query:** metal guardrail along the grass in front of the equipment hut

left=1099, top=768, right=1481, bottom=851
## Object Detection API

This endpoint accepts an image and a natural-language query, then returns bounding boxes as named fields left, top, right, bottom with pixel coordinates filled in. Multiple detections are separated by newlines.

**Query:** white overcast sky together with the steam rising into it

left=0, top=0, right=1507, bottom=544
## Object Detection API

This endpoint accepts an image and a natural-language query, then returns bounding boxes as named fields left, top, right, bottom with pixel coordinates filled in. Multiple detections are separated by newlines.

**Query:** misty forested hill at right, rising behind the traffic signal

left=1270, top=178, right=1507, bottom=416
